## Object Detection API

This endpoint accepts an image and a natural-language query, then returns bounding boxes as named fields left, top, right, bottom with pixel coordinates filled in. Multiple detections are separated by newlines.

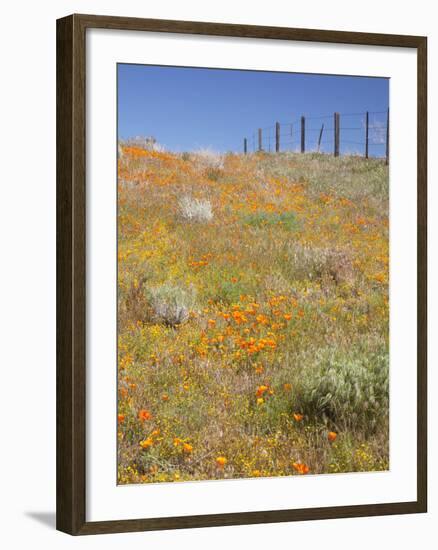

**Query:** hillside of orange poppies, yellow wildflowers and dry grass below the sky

left=118, top=144, right=389, bottom=484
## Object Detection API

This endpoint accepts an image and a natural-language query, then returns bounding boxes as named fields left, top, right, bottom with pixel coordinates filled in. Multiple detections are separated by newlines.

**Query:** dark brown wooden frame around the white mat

left=56, top=15, right=427, bottom=535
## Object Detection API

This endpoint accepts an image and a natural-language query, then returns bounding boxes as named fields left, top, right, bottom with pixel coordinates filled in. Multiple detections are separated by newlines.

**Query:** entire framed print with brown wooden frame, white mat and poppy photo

left=57, top=15, right=427, bottom=535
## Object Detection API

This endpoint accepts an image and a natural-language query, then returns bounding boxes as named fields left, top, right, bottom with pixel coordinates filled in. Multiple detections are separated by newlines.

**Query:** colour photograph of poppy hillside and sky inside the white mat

left=114, top=63, right=390, bottom=485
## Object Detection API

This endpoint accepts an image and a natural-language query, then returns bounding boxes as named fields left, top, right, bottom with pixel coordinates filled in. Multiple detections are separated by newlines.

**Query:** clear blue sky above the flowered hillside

left=118, top=64, right=389, bottom=156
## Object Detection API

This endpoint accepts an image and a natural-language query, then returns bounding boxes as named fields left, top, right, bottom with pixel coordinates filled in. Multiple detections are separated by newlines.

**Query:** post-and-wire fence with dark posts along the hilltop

left=243, top=109, right=389, bottom=164
